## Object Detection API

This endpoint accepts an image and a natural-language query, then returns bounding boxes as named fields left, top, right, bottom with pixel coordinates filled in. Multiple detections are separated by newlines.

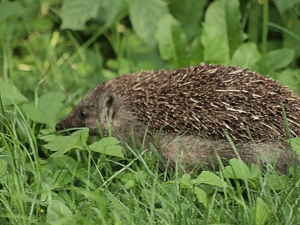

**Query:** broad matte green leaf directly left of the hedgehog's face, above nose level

left=22, top=92, right=65, bottom=126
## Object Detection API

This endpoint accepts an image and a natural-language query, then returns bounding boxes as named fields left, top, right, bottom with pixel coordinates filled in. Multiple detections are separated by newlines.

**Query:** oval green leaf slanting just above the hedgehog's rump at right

left=253, top=48, right=295, bottom=74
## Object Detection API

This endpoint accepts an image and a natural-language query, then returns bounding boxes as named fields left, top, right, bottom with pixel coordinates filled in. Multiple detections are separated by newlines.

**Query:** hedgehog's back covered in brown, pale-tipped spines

left=102, top=64, right=300, bottom=142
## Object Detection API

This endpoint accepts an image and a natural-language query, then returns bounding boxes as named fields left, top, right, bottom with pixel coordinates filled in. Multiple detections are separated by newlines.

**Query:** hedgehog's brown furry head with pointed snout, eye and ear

left=55, top=84, right=116, bottom=135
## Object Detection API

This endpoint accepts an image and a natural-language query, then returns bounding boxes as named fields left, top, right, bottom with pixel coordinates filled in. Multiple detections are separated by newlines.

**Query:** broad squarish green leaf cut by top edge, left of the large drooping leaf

left=61, top=0, right=101, bottom=30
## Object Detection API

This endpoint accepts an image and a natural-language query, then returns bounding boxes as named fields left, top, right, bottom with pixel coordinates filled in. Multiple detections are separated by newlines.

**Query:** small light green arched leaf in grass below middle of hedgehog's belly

left=191, top=171, right=228, bottom=187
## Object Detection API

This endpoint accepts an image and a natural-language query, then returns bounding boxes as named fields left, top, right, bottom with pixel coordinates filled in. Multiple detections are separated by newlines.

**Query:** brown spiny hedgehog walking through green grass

left=56, top=63, right=300, bottom=173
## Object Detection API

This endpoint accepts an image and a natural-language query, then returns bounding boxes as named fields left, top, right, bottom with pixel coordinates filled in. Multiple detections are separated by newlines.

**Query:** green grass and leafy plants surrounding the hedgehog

left=0, top=0, right=300, bottom=225
